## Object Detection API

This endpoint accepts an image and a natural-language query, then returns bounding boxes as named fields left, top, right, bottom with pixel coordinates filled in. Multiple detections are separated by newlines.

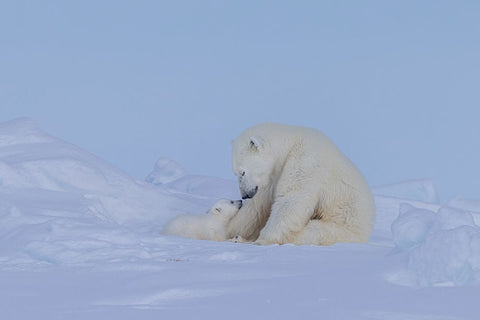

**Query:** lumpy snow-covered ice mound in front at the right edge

left=391, top=204, right=480, bottom=286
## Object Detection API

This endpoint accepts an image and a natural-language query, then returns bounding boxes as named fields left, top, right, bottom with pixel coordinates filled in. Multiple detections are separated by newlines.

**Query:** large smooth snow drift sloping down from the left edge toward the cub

left=0, top=119, right=203, bottom=268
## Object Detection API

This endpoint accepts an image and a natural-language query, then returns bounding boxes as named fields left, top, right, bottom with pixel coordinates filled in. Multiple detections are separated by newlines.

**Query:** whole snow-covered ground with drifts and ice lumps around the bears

left=0, top=119, right=480, bottom=320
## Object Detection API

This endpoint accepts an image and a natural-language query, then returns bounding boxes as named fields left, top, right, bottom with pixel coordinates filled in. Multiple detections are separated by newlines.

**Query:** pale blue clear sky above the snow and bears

left=0, top=1, right=480, bottom=200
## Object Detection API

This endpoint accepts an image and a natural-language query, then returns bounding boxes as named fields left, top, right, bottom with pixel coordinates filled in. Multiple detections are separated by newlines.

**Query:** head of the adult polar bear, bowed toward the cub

left=232, top=131, right=278, bottom=199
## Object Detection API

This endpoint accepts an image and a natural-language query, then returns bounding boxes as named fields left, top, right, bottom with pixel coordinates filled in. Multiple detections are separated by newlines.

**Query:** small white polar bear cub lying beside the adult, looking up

left=162, top=199, right=242, bottom=241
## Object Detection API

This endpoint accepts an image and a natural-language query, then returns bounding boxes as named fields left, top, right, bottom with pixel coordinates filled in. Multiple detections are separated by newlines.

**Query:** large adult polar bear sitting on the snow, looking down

left=227, top=123, right=375, bottom=245
